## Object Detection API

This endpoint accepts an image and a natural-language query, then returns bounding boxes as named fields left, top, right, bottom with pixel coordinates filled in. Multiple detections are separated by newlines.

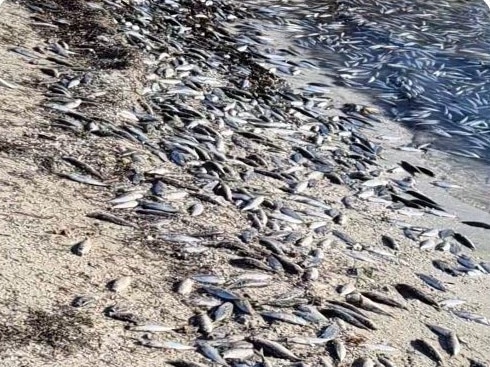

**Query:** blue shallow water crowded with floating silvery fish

left=235, top=0, right=490, bottom=163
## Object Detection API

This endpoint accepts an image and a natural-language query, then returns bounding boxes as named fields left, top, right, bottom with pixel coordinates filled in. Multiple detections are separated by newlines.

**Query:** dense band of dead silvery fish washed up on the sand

left=12, top=0, right=490, bottom=367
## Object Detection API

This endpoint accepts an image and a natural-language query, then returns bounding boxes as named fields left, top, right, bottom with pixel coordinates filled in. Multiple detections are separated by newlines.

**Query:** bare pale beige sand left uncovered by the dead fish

left=0, top=2, right=490, bottom=367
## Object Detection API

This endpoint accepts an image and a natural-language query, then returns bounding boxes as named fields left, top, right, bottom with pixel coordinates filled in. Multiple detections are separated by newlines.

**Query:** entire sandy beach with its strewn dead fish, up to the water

left=0, top=2, right=490, bottom=367
